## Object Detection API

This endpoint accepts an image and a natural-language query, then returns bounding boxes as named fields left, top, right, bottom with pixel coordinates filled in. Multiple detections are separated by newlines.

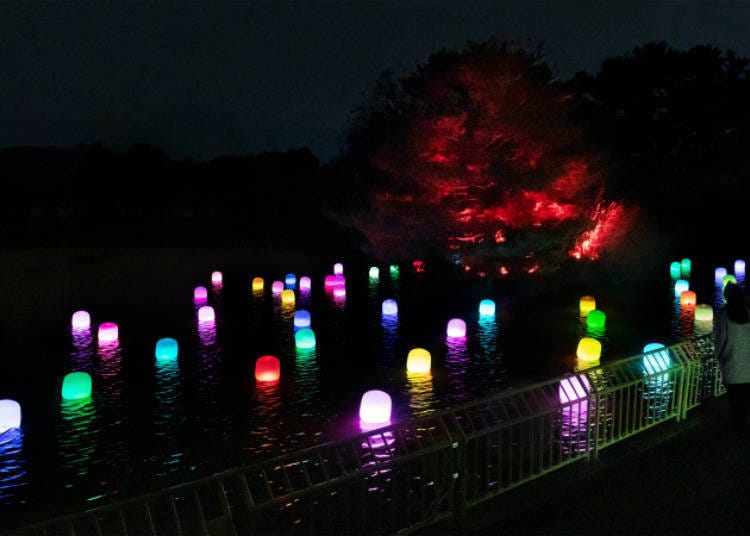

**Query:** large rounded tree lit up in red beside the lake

left=348, top=40, right=624, bottom=274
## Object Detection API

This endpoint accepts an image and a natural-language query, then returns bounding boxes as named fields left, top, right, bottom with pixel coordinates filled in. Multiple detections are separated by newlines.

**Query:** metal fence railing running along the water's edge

left=14, top=336, right=723, bottom=536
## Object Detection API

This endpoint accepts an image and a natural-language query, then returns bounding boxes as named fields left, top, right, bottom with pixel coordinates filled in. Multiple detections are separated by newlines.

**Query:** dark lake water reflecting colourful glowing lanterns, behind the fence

left=0, top=249, right=744, bottom=528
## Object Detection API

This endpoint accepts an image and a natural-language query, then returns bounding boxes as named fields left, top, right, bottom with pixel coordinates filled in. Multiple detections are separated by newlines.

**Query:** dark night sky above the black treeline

left=0, top=1, right=750, bottom=161
